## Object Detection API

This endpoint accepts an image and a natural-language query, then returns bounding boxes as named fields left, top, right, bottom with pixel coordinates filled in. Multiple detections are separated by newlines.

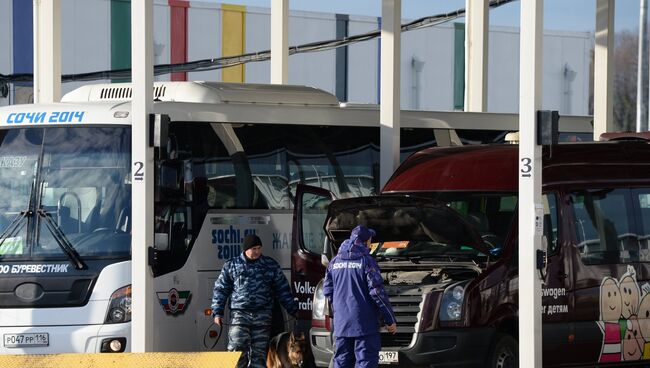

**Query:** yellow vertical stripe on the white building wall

left=221, top=4, right=246, bottom=83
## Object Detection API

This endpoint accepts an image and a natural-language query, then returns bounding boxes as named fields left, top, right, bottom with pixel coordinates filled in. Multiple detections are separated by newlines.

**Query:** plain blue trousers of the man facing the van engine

left=334, top=332, right=381, bottom=368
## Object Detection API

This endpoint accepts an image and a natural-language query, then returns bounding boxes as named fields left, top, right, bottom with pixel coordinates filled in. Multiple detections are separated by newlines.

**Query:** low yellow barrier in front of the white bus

left=0, top=352, right=240, bottom=368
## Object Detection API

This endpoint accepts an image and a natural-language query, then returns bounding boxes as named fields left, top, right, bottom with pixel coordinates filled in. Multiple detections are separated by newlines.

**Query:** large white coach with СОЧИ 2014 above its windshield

left=0, top=82, right=591, bottom=354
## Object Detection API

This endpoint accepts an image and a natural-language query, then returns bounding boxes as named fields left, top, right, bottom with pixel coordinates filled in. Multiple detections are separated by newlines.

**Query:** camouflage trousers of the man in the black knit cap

left=228, top=310, right=272, bottom=368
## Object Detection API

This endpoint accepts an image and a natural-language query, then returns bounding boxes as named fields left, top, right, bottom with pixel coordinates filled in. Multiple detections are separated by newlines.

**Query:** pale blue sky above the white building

left=218, top=0, right=639, bottom=32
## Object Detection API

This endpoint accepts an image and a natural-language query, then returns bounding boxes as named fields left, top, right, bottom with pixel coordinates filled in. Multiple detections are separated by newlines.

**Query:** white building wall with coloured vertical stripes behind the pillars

left=0, top=0, right=593, bottom=114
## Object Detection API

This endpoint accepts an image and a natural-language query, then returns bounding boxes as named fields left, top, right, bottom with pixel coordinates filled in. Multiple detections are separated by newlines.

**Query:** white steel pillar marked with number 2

left=131, top=0, right=155, bottom=353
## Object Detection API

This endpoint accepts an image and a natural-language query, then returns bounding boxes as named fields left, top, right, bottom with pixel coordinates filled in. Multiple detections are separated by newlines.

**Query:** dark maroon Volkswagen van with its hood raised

left=293, top=133, right=650, bottom=367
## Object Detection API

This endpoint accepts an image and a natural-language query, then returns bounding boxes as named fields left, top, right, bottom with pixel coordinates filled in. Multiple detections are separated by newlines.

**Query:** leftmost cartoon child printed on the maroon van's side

left=598, top=277, right=623, bottom=363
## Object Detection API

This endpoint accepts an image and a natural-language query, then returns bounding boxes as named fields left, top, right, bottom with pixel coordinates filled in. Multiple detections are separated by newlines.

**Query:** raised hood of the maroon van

left=324, top=195, right=490, bottom=254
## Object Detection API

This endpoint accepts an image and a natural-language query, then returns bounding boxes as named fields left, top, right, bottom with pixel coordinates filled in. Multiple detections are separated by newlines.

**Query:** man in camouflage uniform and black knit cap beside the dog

left=212, top=235, right=298, bottom=368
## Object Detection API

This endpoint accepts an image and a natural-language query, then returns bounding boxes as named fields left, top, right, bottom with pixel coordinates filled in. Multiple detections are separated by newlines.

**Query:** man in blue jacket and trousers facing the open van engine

left=323, top=225, right=397, bottom=368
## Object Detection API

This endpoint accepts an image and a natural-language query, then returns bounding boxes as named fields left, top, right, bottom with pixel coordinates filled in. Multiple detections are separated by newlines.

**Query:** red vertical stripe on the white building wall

left=169, top=0, right=190, bottom=81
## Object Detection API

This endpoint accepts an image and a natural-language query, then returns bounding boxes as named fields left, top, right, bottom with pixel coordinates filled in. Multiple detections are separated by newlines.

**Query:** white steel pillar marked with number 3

left=518, top=0, right=544, bottom=367
